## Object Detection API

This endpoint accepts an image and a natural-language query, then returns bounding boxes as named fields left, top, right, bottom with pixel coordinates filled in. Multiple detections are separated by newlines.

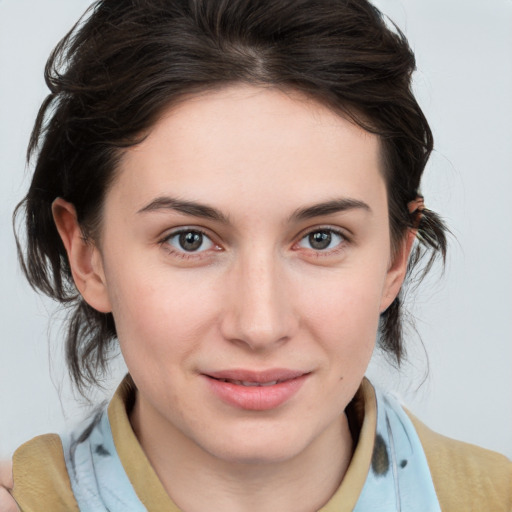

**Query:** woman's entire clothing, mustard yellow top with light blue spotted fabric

left=14, top=378, right=512, bottom=512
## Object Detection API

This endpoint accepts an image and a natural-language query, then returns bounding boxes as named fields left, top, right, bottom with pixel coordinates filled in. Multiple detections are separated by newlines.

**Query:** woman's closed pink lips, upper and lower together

left=202, top=368, right=310, bottom=411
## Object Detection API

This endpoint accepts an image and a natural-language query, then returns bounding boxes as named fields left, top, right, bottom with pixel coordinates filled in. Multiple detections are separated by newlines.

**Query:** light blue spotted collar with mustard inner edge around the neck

left=62, top=376, right=441, bottom=512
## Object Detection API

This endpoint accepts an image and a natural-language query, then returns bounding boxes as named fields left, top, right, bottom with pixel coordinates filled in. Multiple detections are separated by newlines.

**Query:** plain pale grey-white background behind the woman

left=0, top=0, right=512, bottom=458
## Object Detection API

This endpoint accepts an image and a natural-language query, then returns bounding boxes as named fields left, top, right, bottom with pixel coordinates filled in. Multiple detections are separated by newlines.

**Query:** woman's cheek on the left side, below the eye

left=110, top=267, right=219, bottom=364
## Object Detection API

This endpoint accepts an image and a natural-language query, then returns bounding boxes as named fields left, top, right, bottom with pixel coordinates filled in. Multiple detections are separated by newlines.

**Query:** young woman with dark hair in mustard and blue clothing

left=2, top=1, right=511, bottom=511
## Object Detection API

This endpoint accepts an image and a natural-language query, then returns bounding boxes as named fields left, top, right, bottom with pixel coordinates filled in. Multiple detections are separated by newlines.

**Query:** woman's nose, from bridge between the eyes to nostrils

left=221, top=251, right=298, bottom=351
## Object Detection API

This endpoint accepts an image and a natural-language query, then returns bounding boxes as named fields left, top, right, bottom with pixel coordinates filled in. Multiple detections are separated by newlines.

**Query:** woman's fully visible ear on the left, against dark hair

left=52, top=197, right=112, bottom=313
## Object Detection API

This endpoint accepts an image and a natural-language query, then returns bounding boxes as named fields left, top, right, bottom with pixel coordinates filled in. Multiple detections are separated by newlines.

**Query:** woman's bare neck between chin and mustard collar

left=130, top=398, right=353, bottom=512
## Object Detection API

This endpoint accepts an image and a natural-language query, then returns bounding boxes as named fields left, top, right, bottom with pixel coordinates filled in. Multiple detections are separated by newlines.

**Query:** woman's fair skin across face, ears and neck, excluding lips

left=53, top=85, right=414, bottom=512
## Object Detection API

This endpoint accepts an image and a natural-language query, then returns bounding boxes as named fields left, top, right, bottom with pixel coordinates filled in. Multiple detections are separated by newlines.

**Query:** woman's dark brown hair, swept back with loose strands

left=15, top=0, right=446, bottom=391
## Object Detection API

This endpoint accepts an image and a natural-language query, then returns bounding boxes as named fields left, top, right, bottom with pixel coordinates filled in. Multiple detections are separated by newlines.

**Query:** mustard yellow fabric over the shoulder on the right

left=407, top=412, right=512, bottom=512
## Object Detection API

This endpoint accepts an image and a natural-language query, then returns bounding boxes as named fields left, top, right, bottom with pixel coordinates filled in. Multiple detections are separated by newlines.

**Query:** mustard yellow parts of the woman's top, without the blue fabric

left=13, top=378, right=512, bottom=512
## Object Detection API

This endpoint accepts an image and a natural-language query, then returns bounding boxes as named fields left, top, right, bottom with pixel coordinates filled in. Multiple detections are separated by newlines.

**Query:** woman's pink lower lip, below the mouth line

left=205, top=374, right=308, bottom=411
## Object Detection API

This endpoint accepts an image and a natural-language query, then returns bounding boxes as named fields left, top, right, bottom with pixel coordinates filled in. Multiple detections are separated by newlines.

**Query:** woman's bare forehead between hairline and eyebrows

left=113, top=86, right=383, bottom=216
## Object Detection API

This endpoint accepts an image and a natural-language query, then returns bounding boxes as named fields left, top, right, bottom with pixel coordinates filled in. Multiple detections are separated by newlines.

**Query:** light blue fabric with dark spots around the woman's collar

left=58, top=386, right=441, bottom=512
